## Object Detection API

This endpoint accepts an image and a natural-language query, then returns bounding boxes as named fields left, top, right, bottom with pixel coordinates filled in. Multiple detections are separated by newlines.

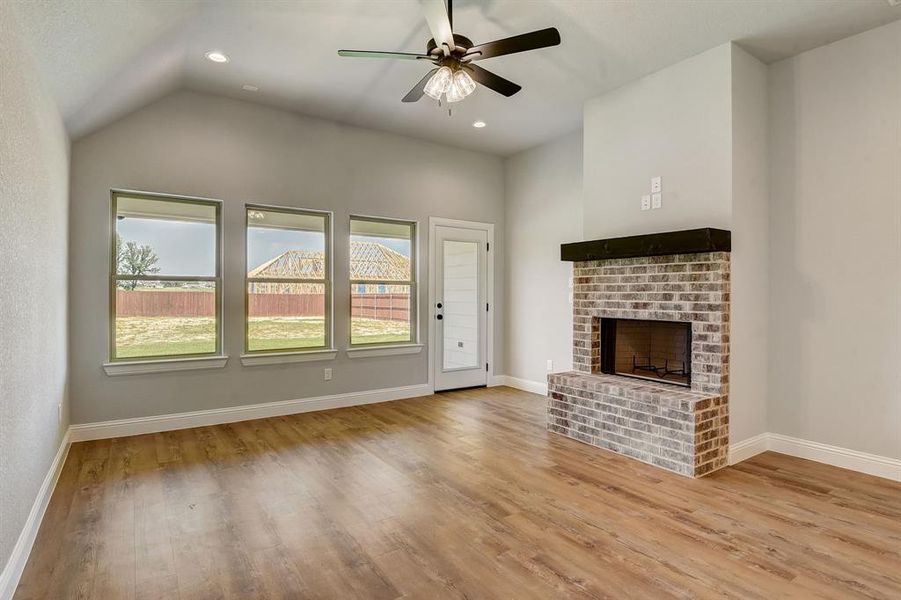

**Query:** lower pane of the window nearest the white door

left=350, top=284, right=412, bottom=344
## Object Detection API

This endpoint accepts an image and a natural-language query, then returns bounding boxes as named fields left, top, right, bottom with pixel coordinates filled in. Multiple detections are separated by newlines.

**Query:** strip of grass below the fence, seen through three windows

left=116, top=317, right=410, bottom=358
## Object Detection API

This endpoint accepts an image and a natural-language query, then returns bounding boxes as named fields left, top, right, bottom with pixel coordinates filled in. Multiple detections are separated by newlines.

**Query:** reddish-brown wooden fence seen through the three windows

left=116, top=290, right=410, bottom=321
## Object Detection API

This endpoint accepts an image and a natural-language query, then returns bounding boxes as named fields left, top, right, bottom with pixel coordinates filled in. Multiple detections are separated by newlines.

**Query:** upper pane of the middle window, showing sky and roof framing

left=247, top=208, right=328, bottom=279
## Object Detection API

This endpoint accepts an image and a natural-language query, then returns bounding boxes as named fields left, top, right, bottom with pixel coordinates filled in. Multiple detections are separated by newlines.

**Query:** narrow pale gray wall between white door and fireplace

left=504, top=131, right=582, bottom=382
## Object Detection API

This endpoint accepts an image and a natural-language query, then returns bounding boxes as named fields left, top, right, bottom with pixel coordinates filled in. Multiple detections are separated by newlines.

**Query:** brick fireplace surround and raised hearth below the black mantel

left=548, top=252, right=730, bottom=477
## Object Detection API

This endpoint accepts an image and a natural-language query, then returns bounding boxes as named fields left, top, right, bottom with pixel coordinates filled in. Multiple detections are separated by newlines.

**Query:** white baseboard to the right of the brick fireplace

left=729, top=433, right=901, bottom=481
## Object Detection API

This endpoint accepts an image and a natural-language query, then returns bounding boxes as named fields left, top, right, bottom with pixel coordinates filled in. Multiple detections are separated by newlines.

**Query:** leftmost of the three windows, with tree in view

left=110, top=192, right=222, bottom=361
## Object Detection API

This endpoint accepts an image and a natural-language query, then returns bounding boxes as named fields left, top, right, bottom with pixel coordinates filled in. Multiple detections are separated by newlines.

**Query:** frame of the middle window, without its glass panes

left=244, top=204, right=335, bottom=357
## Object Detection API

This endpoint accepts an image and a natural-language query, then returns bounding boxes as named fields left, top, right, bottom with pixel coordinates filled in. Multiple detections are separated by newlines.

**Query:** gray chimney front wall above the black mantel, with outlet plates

left=583, top=44, right=732, bottom=239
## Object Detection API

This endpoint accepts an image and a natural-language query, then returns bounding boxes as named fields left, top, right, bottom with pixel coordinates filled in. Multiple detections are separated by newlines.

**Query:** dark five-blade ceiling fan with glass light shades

left=338, top=0, right=560, bottom=103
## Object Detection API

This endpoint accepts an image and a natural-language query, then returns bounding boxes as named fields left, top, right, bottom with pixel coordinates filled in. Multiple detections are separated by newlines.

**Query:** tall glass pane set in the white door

left=442, top=240, right=481, bottom=370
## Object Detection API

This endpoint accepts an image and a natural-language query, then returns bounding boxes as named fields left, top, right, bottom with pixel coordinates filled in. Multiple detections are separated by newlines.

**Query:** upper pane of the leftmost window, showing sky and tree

left=115, top=195, right=216, bottom=277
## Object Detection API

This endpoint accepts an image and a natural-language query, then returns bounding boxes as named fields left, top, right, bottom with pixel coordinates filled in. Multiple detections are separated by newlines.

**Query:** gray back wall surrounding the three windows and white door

left=70, top=92, right=504, bottom=423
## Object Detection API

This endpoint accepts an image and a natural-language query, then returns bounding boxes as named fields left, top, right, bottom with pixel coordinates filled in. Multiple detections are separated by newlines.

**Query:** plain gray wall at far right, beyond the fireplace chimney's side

left=768, top=22, right=901, bottom=458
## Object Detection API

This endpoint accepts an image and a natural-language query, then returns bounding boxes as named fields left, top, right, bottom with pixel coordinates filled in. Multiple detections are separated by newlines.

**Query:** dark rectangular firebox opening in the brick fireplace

left=600, top=318, right=691, bottom=387
